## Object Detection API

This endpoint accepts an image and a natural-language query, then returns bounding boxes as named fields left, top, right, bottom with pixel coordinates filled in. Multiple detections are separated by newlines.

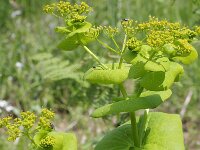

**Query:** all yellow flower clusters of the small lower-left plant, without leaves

left=0, top=108, right=55, bottom=147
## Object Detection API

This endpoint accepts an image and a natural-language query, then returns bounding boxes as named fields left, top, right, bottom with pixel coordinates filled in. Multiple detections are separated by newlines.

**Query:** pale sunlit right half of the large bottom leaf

left=143, top=112, right=185, bottom=150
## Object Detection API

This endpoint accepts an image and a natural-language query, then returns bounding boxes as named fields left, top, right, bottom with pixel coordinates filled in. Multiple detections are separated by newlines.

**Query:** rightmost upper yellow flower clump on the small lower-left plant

left=38, top=108, right=55, bottom=130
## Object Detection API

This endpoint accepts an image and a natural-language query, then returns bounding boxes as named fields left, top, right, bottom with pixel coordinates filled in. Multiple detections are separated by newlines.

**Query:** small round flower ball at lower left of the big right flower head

left=126, top=37, right=142, bottom=51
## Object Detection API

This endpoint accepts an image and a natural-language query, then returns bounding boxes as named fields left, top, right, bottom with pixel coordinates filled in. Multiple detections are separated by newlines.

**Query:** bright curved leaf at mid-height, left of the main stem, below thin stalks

left=84, top=64, right=130, bottom=84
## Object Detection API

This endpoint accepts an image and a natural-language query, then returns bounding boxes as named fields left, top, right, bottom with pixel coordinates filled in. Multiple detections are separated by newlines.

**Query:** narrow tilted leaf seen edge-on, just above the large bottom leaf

left=92, top=90, right=172, bottom=118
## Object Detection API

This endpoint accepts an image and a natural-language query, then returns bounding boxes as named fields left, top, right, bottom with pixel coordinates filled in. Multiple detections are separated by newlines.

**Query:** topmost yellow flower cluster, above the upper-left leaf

left=44, top=1, right=92, bottom=22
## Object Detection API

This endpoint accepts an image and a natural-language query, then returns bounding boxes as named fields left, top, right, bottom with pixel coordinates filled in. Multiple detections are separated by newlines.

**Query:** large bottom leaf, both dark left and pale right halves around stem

left=95, top=112, right=184, bottom=150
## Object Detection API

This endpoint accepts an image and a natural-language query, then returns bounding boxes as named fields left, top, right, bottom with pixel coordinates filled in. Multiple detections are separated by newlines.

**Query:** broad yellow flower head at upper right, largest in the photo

left=121, top=16, right=200, bottom=56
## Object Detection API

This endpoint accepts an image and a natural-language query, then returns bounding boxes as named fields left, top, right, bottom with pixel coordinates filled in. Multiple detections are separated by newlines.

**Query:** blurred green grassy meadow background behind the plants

left=0, top=0, right=200, bottom=150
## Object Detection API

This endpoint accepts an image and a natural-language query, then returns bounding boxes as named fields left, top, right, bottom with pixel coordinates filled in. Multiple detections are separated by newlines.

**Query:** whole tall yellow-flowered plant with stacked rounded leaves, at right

left=44, top=1, right=200, bottom=150
